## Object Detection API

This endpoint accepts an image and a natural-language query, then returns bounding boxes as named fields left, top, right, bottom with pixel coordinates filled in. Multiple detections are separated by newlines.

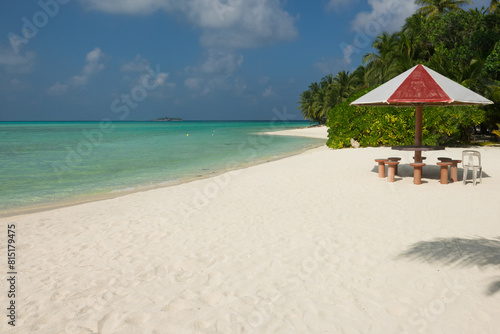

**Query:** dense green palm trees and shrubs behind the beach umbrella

left=298, top=0, right=500, bottom=147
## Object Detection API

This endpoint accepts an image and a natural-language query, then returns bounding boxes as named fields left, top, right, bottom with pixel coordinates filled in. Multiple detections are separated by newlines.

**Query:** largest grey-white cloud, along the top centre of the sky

left=80, top=0, right=297, bottom=48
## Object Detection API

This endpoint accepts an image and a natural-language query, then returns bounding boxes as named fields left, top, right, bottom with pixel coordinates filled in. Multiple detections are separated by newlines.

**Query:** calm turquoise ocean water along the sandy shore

left=0, top=121, right=324, bottom=215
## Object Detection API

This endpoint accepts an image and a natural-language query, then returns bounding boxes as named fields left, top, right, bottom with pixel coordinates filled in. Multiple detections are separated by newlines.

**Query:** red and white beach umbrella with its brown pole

left=351, top=65, right=493, bottom=162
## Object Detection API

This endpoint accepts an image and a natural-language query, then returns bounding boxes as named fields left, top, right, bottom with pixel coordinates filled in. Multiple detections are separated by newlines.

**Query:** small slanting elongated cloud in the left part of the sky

left=48, top=48, right=104, bottom=95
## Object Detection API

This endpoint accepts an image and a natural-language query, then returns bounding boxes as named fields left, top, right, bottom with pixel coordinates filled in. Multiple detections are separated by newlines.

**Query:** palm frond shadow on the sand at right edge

left=397, top=237, right=500, bottom=296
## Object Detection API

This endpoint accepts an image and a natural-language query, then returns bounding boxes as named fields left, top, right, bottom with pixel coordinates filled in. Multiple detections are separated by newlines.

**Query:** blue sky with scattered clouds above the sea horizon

left=0, top=0, right=489, bottom=121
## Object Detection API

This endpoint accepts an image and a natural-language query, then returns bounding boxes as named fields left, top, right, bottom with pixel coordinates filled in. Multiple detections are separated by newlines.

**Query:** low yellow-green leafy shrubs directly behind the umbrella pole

left=327, top=89, right=484, bottom=148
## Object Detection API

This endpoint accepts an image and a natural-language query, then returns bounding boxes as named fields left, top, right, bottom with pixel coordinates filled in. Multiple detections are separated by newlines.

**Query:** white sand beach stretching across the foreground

left=0, top=127, right=500, bottom=334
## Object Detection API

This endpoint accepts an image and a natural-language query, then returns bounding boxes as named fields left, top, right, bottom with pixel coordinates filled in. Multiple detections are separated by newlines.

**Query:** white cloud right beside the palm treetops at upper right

left=351, top=0, right=418, bottom=34
